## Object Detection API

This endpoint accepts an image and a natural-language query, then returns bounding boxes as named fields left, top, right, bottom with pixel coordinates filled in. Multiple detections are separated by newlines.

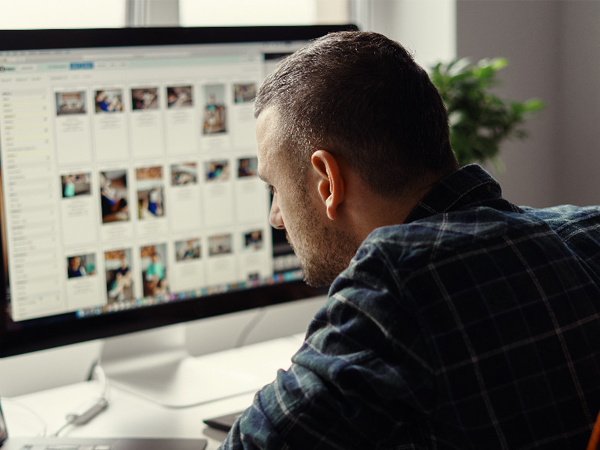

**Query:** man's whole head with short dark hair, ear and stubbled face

left=255, top=32, right=457, bottom=285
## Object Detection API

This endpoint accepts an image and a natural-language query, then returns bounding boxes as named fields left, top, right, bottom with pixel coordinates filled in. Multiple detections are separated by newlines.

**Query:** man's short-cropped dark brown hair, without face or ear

left=255, top=32, right=458, bottom=197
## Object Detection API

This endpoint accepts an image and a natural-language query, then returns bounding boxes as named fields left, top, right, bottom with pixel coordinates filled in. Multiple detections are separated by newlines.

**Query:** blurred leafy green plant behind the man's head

left=430, top=58, right=545, bottom=168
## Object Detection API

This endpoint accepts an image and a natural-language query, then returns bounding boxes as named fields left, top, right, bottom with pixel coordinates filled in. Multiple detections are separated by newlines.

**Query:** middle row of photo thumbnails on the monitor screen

left=61, top=157, right=258, bottom=223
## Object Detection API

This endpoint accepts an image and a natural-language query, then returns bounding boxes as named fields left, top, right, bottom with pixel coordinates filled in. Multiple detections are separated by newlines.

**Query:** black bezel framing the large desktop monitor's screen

left=0, top=25, right=357, bottom=358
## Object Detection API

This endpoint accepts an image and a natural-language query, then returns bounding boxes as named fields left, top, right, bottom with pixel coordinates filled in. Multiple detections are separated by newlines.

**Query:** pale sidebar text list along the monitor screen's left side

left=0, top=89, right=66, bottom=321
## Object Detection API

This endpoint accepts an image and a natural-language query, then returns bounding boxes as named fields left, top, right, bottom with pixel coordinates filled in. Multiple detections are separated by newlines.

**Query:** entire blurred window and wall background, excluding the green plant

left=0, top=0, right=600, bottom=207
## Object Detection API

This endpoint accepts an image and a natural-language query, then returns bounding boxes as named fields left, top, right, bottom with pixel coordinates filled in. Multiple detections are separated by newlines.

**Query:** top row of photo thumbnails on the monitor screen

left=56, top=83, right=256, bottom=134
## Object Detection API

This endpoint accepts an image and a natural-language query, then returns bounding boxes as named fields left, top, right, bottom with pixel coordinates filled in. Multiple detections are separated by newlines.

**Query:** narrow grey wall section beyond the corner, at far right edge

left=556, top=1, right=600, bottom=205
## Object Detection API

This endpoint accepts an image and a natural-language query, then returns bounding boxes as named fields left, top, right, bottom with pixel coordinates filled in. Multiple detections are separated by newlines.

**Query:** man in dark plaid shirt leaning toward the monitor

left=222, top=32, right=600, bottom=450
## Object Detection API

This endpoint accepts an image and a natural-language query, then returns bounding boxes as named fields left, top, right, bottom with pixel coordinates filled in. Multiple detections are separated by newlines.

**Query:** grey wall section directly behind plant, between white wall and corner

left=456, top=0, right=562, bottom=207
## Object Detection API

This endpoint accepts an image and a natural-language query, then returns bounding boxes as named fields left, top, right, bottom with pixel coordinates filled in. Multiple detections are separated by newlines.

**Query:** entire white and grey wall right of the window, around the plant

left=368, top=0, right=600, bottom=207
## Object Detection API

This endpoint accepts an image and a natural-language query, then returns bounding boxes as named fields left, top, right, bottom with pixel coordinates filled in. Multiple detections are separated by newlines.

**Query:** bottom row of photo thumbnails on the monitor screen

left=66, top=230, right=263, bottom=304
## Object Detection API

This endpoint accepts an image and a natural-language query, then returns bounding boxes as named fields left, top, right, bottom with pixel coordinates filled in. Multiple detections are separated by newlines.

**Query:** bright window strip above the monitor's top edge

left=0, top=0, right=350, bottom=29
